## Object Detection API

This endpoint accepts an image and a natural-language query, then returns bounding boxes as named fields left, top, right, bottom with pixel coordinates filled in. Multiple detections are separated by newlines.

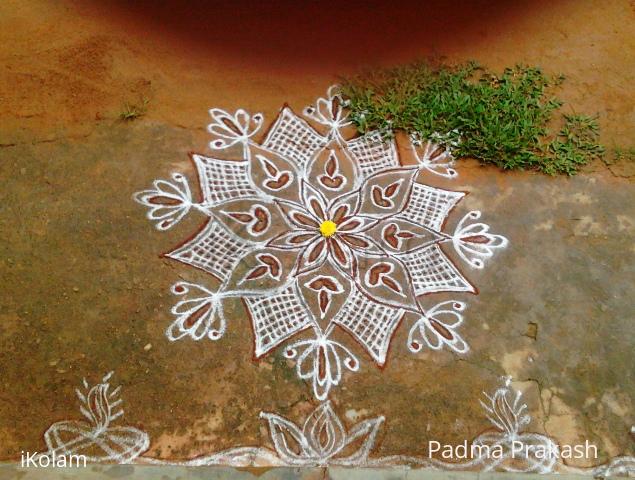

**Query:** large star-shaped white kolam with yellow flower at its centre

left=135, top=87, right=507, bottom=401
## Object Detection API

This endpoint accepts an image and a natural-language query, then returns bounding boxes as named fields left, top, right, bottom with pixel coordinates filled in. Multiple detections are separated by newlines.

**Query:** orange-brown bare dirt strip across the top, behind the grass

left=0, top=0, right=635, bottom=156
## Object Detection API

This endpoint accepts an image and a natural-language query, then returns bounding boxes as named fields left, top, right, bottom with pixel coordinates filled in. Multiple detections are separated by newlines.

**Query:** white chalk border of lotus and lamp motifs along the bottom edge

left=41, top=372, right=635, bottom=472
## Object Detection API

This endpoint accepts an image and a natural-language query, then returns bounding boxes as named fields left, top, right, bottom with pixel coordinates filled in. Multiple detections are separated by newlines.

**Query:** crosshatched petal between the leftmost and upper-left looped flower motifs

left=192, top=154, right=259, bottom=206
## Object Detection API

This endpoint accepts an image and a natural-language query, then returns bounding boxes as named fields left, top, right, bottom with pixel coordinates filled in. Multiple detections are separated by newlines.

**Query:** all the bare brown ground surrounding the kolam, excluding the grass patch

left=0, top=0, right=635, bottom=468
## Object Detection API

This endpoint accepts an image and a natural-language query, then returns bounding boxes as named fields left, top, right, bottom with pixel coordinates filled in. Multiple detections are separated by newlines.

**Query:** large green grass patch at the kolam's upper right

left=341, top=62, right=604, bottom=175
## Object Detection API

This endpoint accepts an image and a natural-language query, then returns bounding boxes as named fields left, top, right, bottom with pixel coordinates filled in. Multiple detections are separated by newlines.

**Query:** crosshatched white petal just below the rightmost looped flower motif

left=399, top=243, right=477, bottom=295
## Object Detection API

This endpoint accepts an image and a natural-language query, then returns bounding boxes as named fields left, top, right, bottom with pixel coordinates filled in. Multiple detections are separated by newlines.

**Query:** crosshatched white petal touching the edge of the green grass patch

left=346, top=132, right=399, bottom=178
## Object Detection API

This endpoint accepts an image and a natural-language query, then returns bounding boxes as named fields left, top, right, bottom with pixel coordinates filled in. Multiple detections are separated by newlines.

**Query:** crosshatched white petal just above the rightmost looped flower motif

left=399, top=183, right=466, bottom=232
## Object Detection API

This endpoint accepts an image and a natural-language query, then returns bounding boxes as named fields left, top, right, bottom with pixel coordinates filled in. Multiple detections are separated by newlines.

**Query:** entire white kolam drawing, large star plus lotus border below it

left=33, top=87, right=635, bottom=477
